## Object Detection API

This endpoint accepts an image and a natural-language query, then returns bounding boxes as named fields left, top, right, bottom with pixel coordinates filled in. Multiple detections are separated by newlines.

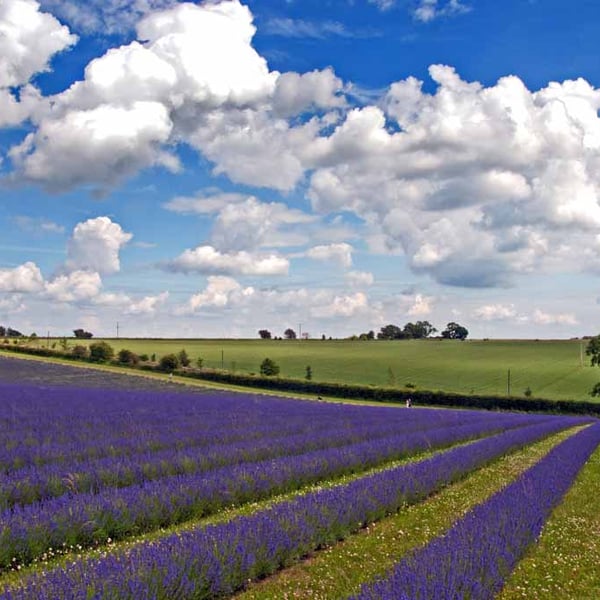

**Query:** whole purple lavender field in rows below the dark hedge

left=0, top=361, right=600, bottom=600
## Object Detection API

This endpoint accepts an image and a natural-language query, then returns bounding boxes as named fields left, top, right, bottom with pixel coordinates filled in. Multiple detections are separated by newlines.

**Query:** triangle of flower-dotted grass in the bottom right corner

left=499, top=440, right=600, bottom=600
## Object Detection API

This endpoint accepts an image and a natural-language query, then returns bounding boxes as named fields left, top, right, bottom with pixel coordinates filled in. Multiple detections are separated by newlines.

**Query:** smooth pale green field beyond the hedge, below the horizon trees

left=69, top=339, right=600, bottom=400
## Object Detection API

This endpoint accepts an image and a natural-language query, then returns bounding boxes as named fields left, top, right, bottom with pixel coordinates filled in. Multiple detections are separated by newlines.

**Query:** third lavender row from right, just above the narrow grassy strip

left=0, top=411, right=548, bottom=568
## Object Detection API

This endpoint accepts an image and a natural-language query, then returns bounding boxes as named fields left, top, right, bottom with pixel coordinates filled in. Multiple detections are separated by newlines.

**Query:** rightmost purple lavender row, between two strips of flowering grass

left=353, top=424, right=600, bottom=600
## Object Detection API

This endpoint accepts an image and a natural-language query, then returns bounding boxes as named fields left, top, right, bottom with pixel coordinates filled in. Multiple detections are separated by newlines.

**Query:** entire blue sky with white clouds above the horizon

left=0, top=0, right=600, bottom=338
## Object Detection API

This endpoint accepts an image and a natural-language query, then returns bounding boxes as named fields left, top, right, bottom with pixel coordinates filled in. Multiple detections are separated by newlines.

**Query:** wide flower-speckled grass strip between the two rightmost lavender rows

left=236, top=430, right=584, bottom=600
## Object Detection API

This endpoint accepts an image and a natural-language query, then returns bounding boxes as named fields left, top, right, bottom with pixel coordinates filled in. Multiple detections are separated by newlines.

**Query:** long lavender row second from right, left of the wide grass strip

left=0, top=419, right=598, bottom=600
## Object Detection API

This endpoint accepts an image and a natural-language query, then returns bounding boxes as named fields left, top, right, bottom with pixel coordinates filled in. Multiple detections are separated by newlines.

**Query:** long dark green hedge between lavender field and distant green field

left=0, top=344, right=600, bottom=416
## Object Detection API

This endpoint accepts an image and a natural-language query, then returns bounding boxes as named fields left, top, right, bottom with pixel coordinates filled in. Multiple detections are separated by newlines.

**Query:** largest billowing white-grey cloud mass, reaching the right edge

left=308, top=65, right=600, bottom=287
